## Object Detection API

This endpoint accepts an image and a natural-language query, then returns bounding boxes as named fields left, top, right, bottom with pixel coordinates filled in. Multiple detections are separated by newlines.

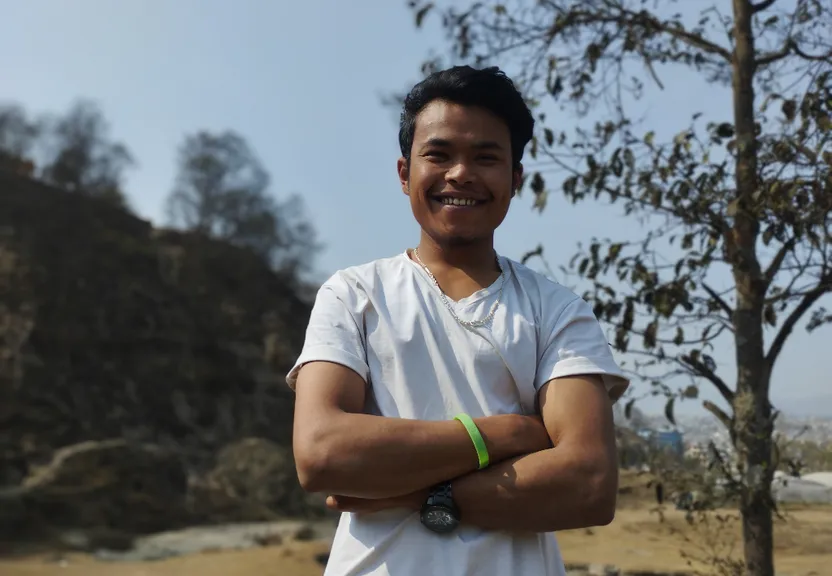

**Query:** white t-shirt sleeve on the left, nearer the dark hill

left=286, top=274, right=370, bottom=390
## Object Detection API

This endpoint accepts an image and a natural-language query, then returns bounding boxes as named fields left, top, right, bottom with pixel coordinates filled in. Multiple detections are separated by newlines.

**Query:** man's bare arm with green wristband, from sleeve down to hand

left=293, top=362, right=549, bottom=499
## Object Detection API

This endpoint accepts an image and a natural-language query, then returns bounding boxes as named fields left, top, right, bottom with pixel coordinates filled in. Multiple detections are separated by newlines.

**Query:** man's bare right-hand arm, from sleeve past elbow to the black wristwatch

left=453, top=376, right=618, bottom=532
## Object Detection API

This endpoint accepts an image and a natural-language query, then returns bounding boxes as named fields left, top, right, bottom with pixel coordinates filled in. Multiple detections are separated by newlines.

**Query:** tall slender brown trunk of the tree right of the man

left=725, top=0, right=774, bottom=576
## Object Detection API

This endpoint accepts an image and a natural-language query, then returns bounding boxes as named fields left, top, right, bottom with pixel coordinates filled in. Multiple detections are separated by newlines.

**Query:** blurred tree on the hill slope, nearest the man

left=168, top=131, right=318, bottom=271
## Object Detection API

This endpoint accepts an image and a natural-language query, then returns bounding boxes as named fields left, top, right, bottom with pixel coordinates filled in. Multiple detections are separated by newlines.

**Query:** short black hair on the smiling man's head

left=399, top=66, right=534, bottom=169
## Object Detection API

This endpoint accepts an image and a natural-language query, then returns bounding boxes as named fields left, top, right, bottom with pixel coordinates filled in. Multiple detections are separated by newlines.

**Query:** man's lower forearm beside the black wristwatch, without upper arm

left=453, top=448, right=618, bottom=532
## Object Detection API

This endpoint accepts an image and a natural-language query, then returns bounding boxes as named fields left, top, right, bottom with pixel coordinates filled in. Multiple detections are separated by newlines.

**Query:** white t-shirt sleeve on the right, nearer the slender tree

left=534, top=297, right=629, bottom=402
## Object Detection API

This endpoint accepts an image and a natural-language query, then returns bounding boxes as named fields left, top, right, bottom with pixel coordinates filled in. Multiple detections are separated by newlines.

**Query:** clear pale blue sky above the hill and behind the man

left=0, top=0, right=832, bottom=408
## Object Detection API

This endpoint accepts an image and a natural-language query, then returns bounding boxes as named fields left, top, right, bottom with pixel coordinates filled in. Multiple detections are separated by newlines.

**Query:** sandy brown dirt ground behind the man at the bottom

left=0, top=474, right=832, bottom=576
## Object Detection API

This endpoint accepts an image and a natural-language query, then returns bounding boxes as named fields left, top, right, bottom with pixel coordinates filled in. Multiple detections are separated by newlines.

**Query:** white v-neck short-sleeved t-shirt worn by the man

left=287, top=253, right=627, bottom=576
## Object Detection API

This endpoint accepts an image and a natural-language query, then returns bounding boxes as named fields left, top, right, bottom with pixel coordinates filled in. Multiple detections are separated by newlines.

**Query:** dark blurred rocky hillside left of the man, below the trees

left=0, top=172, right=318, bottom=534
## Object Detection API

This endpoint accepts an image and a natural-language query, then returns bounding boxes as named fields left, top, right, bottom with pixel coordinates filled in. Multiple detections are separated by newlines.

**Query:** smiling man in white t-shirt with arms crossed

left=287, top=67, right=628, bottom=576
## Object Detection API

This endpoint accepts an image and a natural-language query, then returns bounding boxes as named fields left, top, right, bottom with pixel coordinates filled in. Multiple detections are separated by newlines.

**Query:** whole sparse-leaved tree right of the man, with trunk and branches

left=409, top=0, right=832, bottom=576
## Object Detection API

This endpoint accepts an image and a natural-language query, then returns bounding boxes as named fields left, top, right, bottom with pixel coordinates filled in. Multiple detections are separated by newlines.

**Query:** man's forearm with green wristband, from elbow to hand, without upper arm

left=296, top=413, right=529, bottom=498
